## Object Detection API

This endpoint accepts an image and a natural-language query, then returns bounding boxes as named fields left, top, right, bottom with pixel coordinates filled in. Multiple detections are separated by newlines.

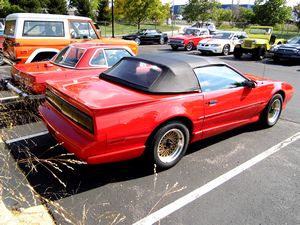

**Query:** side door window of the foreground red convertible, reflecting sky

left=194, top=65, right=246, bottom=92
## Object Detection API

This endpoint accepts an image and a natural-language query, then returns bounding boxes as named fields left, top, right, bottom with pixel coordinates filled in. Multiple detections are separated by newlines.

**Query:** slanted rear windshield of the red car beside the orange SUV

left=54, top=46, right=85, bottom=67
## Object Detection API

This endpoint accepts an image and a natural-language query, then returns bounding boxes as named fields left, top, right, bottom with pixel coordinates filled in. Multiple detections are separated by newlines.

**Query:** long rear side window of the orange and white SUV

left=23, top=21, right=65, bottom=37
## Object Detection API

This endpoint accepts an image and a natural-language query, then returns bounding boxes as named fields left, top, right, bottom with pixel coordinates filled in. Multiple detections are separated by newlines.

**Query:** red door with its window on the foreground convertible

left=195, top=65, right=261, bottom=138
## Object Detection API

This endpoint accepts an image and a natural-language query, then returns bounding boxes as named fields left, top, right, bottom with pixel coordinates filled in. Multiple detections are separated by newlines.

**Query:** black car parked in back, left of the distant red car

left=122, top=29, right=168, bottom=45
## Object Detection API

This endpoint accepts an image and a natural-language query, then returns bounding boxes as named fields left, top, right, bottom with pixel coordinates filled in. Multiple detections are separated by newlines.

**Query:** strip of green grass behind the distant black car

left=100, top=23, right=179, bottom=37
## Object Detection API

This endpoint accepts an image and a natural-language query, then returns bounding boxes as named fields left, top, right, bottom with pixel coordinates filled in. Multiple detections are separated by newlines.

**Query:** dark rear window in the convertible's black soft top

left=104, top=59, right=162, bottom=88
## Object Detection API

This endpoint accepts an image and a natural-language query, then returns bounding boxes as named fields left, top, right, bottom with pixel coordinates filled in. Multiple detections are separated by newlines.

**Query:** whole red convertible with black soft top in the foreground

left=39, top=54, right=293, bottom=169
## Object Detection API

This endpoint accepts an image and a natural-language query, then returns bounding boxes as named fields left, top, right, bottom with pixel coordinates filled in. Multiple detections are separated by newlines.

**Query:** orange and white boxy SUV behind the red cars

left=3, top=13, right=137, bottom=64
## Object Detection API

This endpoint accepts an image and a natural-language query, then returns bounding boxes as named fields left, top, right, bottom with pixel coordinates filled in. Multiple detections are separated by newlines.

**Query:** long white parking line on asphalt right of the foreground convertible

left=133, top=132, right=300, bottom=225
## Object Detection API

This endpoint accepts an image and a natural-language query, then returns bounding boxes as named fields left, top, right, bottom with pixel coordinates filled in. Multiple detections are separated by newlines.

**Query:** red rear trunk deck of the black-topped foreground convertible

left=47, top=77, right=158, bottom=110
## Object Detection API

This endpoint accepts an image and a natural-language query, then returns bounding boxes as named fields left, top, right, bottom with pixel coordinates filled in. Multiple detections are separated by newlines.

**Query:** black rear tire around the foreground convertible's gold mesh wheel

left=147, top=121, right=190, bottom=169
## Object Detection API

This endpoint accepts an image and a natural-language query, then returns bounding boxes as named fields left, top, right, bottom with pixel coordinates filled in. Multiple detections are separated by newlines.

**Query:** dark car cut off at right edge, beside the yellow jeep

left=270, top=36, right=300, bottom=61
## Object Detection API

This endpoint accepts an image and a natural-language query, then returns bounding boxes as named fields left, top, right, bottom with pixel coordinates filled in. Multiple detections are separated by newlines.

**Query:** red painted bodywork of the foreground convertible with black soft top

left=39, top=66, right=293, bottom=164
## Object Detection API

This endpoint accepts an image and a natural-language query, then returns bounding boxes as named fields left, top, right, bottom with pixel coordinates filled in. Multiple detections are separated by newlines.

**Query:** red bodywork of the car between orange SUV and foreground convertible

left=11, top=43, right=133, bottom=94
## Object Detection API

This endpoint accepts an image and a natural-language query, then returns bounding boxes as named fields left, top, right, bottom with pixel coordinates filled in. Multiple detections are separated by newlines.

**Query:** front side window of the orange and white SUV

left=70, top=21, right=98, bottom=39
